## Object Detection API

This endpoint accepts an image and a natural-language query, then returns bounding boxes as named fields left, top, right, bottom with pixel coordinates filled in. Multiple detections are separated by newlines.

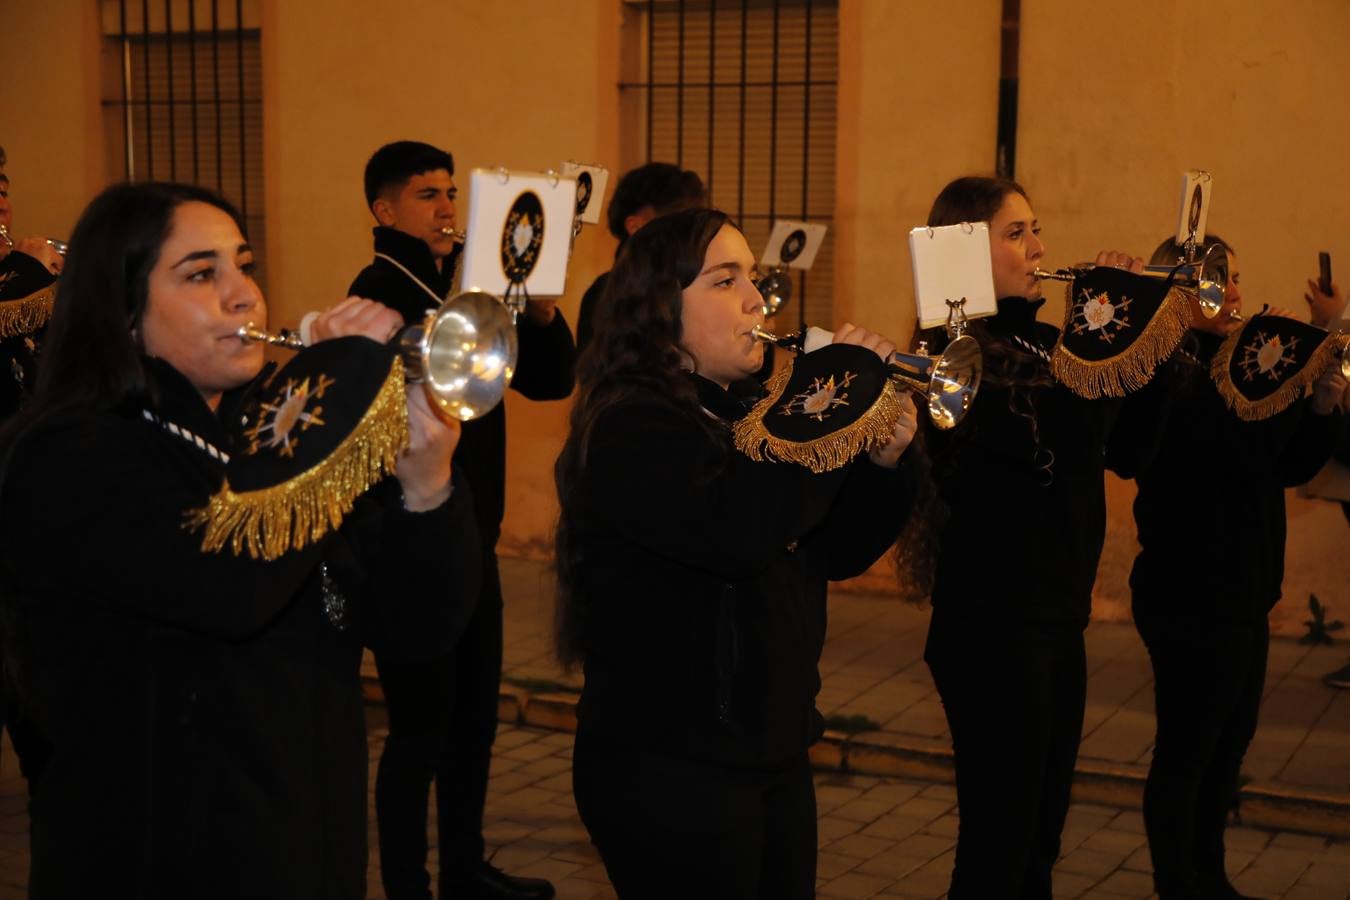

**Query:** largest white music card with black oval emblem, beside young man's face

left=460, top=169, right=576, bottom=297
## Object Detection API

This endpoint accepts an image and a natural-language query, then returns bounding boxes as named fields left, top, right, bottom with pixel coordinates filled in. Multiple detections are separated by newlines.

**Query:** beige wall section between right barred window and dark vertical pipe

left=834, top=0, right=1002, bottom=350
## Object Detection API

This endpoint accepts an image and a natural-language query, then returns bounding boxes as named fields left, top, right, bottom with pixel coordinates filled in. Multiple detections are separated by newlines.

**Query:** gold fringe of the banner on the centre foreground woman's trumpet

left=732, top=366, right=900, bottom=474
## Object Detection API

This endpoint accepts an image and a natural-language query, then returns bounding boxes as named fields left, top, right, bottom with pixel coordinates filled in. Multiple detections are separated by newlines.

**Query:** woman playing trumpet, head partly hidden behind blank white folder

left=899, top=177, right=1166, bottom=900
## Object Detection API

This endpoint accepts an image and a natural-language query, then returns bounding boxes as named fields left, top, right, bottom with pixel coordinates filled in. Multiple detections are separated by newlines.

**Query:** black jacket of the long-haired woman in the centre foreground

left=571, top=379, right=923, bottom=768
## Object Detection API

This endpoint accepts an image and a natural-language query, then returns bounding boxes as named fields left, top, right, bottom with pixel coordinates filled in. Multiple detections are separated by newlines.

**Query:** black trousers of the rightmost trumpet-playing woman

left=1139, top=622, right=1270, bottom=900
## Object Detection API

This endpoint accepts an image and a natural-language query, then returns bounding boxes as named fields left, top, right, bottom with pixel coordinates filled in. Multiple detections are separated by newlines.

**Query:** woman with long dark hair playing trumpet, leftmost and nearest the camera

left=0, top=184, right=477, bottom=900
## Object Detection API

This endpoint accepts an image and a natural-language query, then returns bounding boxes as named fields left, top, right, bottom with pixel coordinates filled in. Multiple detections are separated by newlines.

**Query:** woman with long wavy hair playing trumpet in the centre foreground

left=555, top=209, right=922, bottom=900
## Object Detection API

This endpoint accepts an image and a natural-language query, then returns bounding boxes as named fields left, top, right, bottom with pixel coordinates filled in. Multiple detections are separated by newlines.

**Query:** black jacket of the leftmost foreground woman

left=0, top=360, right=479, bottom=900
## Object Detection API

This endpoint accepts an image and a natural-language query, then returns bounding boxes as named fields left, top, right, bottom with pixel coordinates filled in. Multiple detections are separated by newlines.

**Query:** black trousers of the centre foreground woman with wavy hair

left=572, top=729, right=815, bottom=900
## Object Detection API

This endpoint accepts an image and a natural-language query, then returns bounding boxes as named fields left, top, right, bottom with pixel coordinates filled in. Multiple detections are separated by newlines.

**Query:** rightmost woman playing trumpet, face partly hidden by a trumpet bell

left=1130, top=235, right=1346, bottom=900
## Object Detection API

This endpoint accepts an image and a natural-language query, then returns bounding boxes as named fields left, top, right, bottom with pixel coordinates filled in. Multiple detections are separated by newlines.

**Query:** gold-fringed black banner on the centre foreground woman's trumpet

left=734, top=344, right=900, bottom=472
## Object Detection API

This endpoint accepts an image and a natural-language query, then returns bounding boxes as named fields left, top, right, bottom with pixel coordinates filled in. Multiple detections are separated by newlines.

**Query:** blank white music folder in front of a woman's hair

left=910, top=221, right=998, bottom=328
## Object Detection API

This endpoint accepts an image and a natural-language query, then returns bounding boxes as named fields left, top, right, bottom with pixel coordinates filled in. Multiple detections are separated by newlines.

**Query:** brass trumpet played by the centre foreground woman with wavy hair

left=751, top=325, right=984, bottom=430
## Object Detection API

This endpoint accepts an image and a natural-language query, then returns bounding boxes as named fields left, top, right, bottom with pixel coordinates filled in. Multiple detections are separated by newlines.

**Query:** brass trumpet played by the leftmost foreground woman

left=238, top=291, right=520, bottom=422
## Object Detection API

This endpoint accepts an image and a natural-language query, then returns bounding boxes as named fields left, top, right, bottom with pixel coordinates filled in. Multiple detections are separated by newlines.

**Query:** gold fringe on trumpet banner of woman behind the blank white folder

left=1050, top=283, right=1191, bottom=399
